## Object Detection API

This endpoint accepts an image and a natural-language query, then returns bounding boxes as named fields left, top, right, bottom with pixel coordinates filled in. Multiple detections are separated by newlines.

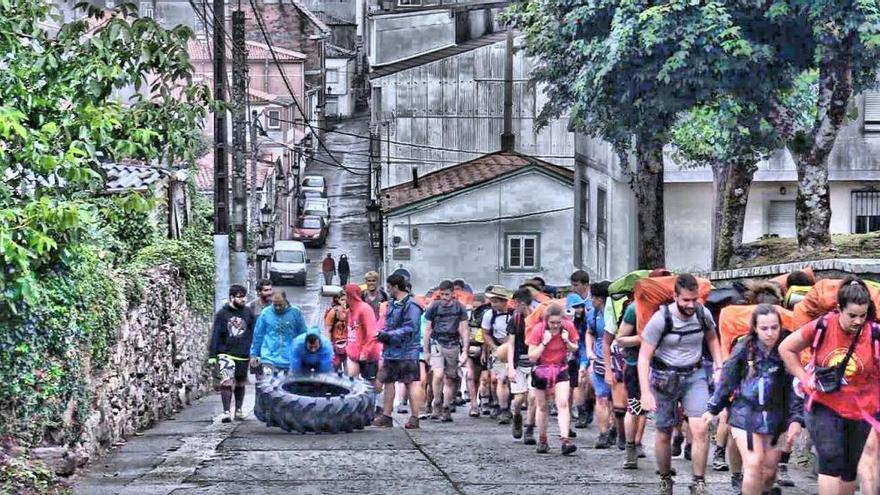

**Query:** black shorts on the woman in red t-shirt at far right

left=806, top=403, right=871, bottom=481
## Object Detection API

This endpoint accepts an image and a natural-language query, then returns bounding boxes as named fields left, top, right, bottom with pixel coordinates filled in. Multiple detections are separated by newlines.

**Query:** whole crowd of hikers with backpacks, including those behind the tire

left=210, top=268, right=880, bottom=495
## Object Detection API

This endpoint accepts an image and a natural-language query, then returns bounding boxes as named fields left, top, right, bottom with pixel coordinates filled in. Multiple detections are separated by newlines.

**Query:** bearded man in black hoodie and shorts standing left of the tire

left=208, top=285, right=254, bottom=423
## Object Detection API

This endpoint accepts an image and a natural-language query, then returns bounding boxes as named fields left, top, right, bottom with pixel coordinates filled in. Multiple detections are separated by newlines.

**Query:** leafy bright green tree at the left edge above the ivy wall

left=0, top=0, right=209, bottom=312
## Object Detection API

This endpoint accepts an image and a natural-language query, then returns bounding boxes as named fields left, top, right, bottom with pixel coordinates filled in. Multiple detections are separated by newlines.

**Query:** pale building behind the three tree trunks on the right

left=574, top=92, right=880, bottom=278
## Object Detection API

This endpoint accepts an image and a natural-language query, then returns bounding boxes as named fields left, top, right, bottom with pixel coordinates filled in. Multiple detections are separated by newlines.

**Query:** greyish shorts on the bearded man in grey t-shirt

left=651, top=366, right=709, bottom=433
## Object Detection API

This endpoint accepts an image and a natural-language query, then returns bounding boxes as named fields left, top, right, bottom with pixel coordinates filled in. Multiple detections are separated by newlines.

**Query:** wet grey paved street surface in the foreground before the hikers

left=74, top=387, right=815, bottom=495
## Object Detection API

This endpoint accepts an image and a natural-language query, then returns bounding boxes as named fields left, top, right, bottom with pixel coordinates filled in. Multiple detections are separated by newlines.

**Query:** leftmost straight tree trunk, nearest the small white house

left=633, top=139, right=666, bottom=269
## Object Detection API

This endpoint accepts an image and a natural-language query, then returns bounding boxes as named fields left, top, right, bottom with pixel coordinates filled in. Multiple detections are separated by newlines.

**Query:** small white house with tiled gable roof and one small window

left=382, top=152, right=574, bottom=293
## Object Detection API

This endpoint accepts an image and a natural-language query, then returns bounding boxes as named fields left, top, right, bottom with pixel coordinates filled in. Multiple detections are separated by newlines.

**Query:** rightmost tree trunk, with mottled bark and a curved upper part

left=795, top=40, right=853, bottom=251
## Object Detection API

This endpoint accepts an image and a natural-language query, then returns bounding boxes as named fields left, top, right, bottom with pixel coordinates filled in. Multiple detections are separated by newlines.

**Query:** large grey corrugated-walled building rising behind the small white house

left=370, top=32, right=574, bottom=187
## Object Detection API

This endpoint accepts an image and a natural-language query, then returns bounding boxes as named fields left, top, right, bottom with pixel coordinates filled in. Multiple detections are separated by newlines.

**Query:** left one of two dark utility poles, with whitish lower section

left=213, top=0, right=229, bottom=311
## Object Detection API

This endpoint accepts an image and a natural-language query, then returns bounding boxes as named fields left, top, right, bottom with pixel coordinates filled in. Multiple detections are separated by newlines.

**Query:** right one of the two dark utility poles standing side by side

left=231, top=9, right=248, bottom=287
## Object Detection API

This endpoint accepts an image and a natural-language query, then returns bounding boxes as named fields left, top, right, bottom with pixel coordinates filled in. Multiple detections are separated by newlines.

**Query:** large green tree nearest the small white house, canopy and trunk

left=509, top=0, right=768, bottom=267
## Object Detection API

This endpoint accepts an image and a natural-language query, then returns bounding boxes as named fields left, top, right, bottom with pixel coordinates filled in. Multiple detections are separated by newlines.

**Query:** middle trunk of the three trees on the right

left=712, top=159, right=757, bottom=270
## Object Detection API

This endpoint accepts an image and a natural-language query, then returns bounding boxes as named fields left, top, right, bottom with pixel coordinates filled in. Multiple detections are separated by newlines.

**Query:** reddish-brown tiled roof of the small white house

left=382, top=151, right=574, bottom=211
